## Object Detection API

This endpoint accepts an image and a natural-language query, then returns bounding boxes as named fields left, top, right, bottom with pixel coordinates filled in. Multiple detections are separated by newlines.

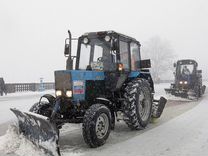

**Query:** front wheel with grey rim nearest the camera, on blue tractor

left=82, top=104, right=112, bottom=148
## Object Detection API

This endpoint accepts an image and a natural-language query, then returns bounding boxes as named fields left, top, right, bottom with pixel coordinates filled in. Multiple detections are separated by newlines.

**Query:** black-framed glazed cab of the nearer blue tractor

left=65, top=31, right=153, bottom=91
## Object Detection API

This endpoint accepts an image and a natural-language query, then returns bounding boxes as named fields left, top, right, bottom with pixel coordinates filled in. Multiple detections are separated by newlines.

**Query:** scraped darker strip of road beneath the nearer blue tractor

left=57, top=97, right=202, bottom=155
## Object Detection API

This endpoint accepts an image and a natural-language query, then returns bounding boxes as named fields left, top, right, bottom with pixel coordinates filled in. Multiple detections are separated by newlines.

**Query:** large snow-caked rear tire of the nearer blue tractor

left=123, top=79, right=152, bottom=130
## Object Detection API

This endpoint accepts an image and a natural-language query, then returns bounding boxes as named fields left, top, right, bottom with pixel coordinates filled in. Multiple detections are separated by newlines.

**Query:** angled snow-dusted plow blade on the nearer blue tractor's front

left=10, top=108, right=60, bottom=156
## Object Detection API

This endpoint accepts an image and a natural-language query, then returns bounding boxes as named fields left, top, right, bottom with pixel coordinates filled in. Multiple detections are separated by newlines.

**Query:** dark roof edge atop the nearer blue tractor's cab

left=82, top=30, right=139, bottom=42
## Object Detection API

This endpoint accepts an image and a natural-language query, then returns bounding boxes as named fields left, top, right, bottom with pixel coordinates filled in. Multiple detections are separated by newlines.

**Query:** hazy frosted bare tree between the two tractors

left=141, top=36, right=176, bottom=82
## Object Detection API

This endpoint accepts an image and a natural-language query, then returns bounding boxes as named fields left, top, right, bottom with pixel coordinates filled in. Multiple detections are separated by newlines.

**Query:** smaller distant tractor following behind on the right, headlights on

left=165, top=59, right=206, bottom=99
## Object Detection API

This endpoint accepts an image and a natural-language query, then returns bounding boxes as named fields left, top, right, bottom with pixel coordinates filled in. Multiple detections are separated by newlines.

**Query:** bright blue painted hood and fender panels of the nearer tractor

left=56, top=70, right=140, bottom=101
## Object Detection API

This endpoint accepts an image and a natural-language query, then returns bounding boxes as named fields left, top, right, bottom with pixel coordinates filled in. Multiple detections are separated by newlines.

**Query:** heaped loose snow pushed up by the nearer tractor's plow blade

left=0, top=124, right=82, bottom=156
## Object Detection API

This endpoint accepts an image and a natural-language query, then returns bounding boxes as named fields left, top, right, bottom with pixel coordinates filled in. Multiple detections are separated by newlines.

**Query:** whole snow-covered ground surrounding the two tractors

left=0, top=83, right=208, bottom=156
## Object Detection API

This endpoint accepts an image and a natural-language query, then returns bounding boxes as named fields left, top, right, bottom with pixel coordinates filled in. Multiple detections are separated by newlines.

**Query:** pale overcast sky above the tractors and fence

left=0, top=0, right=208, bottom=82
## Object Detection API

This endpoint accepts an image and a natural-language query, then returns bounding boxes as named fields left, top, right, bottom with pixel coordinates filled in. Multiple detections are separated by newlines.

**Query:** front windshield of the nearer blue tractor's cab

left=79, top=38, right=112, bottom=70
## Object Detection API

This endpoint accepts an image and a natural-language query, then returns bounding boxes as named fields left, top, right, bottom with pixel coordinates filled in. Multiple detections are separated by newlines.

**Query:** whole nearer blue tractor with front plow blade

left=11, top=31, right=167, bottom=156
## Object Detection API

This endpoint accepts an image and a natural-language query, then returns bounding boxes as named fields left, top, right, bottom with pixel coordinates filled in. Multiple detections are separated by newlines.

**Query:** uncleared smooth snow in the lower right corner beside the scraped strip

left=84, top=92, right=208, bottom=156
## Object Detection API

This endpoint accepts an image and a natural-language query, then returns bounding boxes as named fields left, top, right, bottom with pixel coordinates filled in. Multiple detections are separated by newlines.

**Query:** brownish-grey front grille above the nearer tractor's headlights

left=55, top=71, right=72, bottom=91
